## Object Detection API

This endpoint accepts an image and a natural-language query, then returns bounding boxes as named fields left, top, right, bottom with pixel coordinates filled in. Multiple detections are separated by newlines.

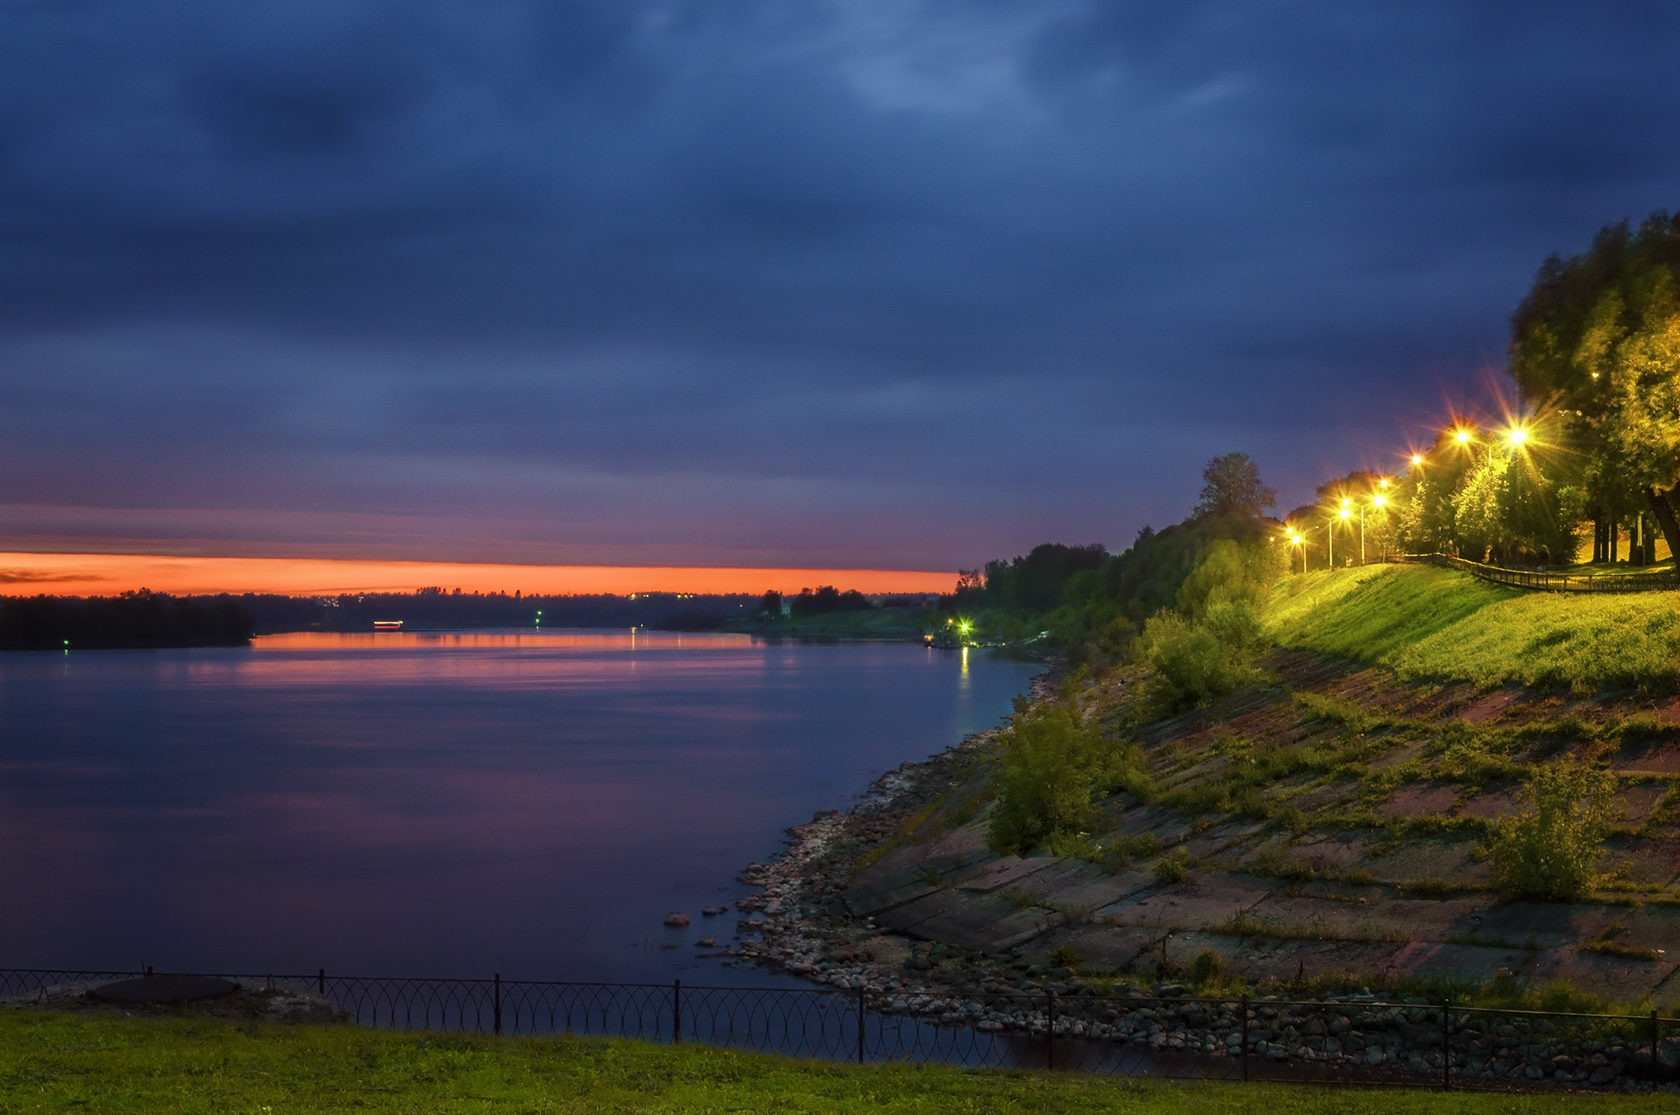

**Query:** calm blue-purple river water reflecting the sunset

left=0, top=631, right=1035, bottom=984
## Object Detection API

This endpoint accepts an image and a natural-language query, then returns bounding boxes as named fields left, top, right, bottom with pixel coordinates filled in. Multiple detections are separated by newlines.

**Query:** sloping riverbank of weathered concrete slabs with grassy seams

left=729, top=634, right=1680, bottom=1013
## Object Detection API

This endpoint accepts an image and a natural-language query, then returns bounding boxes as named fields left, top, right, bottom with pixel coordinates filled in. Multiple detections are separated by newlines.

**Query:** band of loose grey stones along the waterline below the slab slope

left=734, top=715, right=1680, bottom=1090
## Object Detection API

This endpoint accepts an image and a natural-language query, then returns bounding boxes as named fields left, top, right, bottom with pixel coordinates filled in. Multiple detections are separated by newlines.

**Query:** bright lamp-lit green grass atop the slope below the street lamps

left=1265, top=566, right=1680, bottom=692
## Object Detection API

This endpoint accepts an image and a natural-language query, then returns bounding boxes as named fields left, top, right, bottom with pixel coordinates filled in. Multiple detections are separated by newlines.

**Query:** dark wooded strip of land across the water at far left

left=0, top=589, right=255, bottom=650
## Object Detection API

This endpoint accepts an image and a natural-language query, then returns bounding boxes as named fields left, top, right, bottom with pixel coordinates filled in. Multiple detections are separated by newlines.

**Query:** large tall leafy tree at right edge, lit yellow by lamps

left=1507, top=213, right=1680, bottom=567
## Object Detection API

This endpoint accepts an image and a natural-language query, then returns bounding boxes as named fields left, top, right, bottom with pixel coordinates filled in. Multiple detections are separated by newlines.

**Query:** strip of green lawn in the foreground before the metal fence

left=0, top=1009, right=1653, bottom=1115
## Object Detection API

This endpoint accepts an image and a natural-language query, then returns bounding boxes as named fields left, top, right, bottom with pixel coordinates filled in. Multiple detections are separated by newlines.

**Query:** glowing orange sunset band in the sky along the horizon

left=0, top=552, right=956, bottom=596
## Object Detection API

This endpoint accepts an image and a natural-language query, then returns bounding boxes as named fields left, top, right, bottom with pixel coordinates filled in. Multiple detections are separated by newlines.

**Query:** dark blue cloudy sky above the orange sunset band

left=0, top=0, right=1680, bottom=591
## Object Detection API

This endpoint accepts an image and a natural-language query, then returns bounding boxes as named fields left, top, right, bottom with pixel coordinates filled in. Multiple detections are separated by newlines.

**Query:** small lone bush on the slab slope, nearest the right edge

left=1488, top=759, right=1616, bottom=902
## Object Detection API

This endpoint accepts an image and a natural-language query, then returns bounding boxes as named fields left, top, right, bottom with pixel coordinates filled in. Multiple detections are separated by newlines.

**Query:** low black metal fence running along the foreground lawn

left=0, top=969, right=1680, bottom=1090
